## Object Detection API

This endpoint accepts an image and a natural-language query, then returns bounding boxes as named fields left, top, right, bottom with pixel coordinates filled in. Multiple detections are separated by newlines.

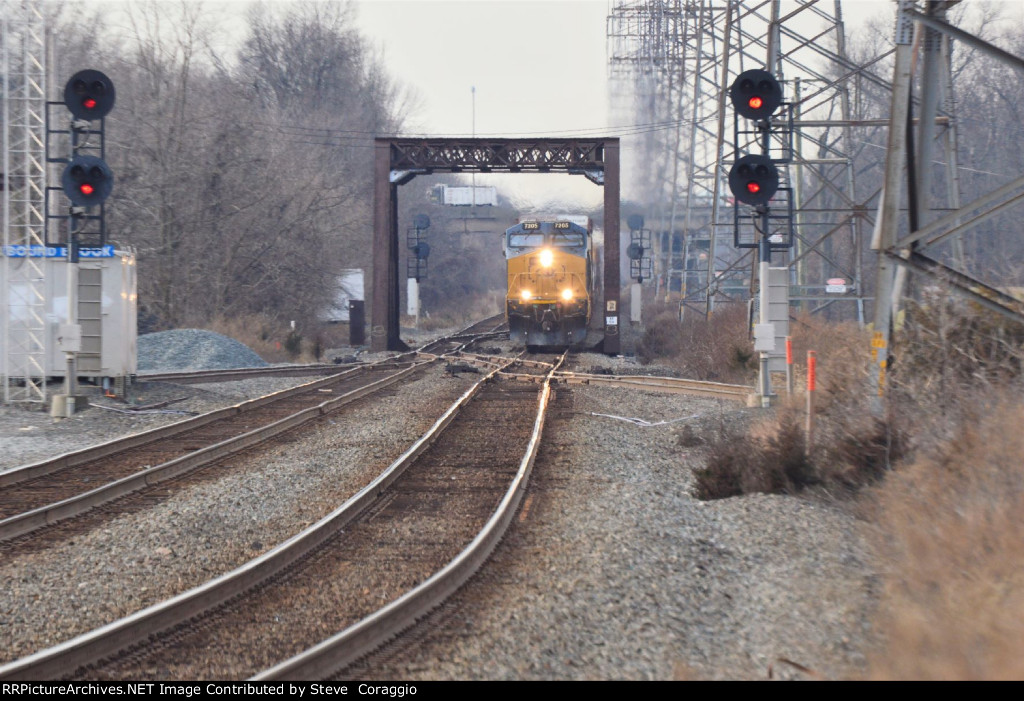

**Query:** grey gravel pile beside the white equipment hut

left=138, top=328, right=267, bottom=373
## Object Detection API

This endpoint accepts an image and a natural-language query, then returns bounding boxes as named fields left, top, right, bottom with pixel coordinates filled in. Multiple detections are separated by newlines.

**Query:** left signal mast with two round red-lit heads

left=47, top=69, right=117, bottom=417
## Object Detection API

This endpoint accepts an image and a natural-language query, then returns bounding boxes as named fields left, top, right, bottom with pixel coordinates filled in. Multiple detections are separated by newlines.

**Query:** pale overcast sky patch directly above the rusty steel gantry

left=358, top=0, right=608, bottom=135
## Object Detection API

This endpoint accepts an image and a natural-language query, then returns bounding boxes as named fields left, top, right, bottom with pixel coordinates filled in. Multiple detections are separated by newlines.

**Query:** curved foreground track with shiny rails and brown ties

left=0, top=349, right=561, bottom=680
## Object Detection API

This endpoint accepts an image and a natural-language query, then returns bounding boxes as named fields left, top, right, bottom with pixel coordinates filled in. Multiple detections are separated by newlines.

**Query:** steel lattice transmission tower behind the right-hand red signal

left=608, top=0, right=890, bottom=321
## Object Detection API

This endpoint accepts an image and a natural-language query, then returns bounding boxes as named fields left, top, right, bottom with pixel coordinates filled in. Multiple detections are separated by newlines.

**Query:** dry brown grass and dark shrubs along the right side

left=647, top=299, right=1024, bottom=680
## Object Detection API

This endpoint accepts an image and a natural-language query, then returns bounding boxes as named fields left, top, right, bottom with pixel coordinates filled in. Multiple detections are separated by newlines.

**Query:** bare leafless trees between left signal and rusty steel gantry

left=51, top=0, right=412, bottom=332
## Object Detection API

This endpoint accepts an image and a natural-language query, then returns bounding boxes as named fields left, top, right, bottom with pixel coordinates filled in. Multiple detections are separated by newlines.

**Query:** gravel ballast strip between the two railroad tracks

left=0, top=367, right=469, bottom=662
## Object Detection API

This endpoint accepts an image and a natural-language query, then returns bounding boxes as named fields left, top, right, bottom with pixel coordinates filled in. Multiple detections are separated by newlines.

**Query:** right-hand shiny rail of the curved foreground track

left=252, top=353, right=565, bottom=681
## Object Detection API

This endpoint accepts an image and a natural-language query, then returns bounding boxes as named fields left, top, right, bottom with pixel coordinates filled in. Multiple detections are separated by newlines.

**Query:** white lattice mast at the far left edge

left=0, top=0, right=46, bottom=403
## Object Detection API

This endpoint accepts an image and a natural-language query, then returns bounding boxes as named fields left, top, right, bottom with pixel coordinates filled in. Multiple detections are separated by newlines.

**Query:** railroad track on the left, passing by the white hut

left=0, top=319, right=505, bottom=549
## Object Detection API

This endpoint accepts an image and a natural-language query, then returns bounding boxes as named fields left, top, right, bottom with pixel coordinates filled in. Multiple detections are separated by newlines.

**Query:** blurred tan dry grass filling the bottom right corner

left=871, top=399, right=1024, bottom=680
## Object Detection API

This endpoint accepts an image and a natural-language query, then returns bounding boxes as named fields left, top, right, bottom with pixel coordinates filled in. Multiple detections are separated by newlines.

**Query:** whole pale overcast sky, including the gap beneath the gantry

left=83, top=0, right=1024, bottom=209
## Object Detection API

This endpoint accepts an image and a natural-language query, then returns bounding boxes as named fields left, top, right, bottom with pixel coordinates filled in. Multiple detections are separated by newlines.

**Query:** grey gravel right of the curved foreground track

left=344, top=387, right=876, bottom=681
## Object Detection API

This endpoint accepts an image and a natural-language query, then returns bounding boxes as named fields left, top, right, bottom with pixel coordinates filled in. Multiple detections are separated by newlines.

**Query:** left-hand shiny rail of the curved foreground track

left=0, top=356, right=520, bottom=680
